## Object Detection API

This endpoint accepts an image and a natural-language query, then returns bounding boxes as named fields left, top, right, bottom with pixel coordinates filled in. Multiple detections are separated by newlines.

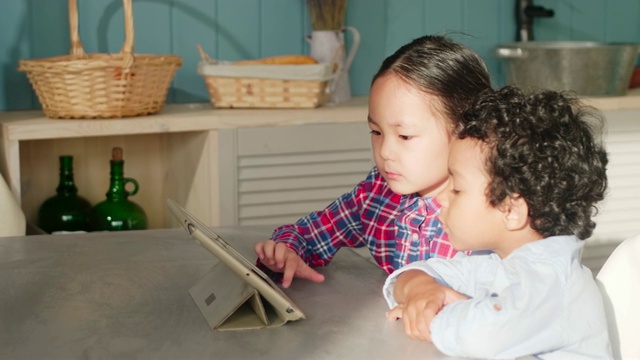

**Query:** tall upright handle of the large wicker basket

left=69, top=0, right=134, bottom=75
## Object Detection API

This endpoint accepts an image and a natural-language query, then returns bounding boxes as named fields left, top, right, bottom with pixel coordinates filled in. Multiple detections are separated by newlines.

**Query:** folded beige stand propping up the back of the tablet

left=189, top=262, right=287, bottom=330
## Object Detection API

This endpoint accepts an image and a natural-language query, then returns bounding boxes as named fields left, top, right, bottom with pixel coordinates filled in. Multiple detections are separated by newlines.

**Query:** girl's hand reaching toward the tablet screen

left=254, top=240, right=324, bottom=288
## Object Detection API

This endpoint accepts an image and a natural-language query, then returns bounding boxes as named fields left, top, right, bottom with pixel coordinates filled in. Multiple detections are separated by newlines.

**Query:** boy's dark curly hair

left=458, top=86, right=608, bottom=240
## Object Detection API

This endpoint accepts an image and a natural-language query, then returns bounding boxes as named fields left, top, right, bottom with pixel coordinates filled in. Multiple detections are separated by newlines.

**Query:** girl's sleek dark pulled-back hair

left=371, top=35, right=491, bottom=125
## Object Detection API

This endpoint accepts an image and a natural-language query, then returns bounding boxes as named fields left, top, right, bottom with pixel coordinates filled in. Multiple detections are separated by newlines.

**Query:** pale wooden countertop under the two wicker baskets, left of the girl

left=0, top=97, right=367, bottom=141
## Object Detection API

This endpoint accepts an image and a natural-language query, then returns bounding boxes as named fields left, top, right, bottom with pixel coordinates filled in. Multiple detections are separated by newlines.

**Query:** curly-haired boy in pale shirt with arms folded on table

left=384, top=87, right=611, bottom=358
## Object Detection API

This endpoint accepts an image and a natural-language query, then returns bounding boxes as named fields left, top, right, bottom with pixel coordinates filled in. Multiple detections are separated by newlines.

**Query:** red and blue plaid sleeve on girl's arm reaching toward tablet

left=271, top=170, right=375, bottom=266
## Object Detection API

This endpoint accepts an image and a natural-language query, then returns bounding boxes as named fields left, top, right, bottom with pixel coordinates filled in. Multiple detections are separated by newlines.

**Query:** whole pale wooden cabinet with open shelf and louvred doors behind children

left=0, top=89, right=640, bottom=236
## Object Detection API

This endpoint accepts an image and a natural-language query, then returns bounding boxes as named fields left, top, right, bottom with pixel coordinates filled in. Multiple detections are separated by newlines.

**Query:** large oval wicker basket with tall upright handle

left=18, top=0, right=182, bottom=119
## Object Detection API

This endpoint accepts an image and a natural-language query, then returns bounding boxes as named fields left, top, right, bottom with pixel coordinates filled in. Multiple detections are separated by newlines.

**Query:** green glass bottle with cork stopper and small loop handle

left=89, top=147, right=147, bottom=231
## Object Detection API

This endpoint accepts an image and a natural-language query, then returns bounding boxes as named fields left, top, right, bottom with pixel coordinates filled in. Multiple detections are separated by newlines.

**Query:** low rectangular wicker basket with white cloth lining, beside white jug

left=198, top=46, right=335, bottom=109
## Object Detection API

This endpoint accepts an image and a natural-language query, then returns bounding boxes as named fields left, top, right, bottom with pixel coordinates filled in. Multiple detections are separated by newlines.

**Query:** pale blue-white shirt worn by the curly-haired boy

left=383, top=236, right=612, bottom=359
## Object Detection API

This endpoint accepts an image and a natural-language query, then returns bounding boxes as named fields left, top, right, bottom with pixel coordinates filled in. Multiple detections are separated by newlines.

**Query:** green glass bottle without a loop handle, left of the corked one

left=38, top=155, right=91, bottom=233
